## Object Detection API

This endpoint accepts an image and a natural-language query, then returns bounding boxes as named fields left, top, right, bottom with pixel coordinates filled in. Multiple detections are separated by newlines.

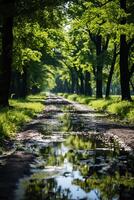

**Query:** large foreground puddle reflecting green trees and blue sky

left=14, top=135, right=134, bottom=200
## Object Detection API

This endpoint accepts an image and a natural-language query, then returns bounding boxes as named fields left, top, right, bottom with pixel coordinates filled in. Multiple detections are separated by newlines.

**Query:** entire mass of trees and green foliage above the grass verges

left=0, top=0, right=134, bottom=106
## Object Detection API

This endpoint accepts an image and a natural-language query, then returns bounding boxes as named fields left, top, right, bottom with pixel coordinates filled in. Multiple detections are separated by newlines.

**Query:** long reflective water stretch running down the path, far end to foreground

left=15, top=98, right=134, bottom=200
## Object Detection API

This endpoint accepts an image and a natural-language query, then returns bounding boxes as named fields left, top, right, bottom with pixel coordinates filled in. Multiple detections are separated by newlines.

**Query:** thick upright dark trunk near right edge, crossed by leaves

left=120, top=0, right=131, bottom=101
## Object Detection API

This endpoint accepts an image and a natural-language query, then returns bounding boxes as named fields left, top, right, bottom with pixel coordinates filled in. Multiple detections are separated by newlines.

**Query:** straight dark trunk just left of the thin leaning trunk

left=96, top=35, right=103, bottom=98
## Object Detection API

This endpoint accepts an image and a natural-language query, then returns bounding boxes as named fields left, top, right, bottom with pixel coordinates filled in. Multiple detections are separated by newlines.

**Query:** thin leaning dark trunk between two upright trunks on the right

left=106, top=44, right=117, bottom=98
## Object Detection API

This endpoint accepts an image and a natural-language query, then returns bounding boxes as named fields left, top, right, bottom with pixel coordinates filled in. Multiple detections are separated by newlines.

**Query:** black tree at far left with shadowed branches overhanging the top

left=0, top=0, right=73, bottom=107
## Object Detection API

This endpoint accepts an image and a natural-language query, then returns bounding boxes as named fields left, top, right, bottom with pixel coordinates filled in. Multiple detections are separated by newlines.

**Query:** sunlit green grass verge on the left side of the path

left=0, top=94, right=45, bottom=141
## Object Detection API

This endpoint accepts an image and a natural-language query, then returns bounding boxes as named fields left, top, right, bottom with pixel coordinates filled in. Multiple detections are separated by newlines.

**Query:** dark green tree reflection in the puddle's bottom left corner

left=23, top=178, right=71, bottom=200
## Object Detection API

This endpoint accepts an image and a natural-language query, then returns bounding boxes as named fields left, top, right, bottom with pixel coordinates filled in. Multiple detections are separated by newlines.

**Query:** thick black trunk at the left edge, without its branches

left=0, top=16, right=13, bottom=107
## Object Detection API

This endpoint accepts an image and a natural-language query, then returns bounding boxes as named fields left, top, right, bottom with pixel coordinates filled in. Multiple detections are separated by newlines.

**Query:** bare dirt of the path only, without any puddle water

left=0, top=95, right=134, bottom=200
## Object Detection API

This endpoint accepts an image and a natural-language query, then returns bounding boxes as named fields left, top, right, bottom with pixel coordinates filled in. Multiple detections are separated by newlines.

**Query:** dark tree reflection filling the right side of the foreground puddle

left=66, top=136, right=134, bottom=200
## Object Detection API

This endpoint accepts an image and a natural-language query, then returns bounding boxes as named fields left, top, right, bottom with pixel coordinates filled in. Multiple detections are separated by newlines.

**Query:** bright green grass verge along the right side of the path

left=60, top=93, right=134, bottom=123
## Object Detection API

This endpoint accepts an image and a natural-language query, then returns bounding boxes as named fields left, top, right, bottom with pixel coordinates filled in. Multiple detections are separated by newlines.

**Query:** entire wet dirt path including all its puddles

left=0, top=95, right=134, bottom=200
